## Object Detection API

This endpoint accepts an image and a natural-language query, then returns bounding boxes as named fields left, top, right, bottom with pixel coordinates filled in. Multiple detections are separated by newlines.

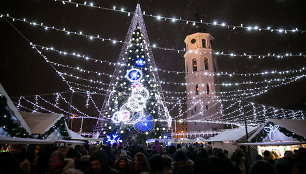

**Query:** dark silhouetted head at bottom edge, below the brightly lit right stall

left=249, top=160, right=276, bottom=174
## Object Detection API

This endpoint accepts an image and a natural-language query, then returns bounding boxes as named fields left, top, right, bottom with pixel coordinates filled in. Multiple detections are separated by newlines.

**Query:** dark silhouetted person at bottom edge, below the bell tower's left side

left=171, top=150, right=194, bottom=174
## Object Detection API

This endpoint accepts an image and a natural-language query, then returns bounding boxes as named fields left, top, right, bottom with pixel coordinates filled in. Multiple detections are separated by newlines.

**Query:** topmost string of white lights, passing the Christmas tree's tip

left=55, top=0, right=306, bottom=34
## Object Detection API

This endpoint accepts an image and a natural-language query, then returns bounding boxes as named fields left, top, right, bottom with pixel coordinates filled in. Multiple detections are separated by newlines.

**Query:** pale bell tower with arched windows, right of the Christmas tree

left=184, top=32, right=223, bottom=137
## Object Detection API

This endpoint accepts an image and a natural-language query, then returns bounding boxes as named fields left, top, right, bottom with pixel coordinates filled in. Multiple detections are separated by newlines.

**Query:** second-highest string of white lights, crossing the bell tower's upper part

left=0, top=13, right=306, bottom=59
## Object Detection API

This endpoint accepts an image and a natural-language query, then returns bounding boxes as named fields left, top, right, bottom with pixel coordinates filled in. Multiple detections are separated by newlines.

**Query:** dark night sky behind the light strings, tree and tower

left=0, top=0, right=306, bottom=130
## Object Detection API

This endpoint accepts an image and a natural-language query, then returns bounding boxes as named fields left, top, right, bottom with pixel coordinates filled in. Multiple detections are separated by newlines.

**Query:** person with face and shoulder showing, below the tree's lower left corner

left=89, top=151, right=119, bottom=174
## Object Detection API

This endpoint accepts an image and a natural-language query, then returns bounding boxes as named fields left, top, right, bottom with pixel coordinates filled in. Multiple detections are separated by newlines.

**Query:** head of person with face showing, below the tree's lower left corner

left=89, top=151, right=109, bottom=174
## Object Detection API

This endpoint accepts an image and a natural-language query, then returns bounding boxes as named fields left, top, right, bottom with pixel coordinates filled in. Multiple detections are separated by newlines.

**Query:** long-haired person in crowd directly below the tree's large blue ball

left=133, top=152, right=151, bottom=174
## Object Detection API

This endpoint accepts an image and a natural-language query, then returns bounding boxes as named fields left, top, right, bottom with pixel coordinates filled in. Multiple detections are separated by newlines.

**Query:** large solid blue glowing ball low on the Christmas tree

left=134, top=114, right=154, bottom=132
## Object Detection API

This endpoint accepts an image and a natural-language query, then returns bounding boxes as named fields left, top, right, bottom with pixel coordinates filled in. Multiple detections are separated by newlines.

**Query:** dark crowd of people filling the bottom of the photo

left=0, top=141, right=306, bottom=174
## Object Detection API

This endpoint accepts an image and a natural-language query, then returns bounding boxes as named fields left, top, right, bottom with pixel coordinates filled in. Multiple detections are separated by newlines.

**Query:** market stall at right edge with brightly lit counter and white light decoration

left=240, top=119, right=306, bottom=157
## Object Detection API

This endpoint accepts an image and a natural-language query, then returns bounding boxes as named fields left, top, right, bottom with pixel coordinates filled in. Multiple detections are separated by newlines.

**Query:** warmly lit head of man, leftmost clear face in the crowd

left=48, top=151, right=65, bottom=172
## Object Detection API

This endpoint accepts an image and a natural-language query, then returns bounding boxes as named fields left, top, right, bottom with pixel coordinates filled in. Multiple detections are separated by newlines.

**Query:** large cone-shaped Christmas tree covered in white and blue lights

left=95, top=4, right=171, bottom=143
